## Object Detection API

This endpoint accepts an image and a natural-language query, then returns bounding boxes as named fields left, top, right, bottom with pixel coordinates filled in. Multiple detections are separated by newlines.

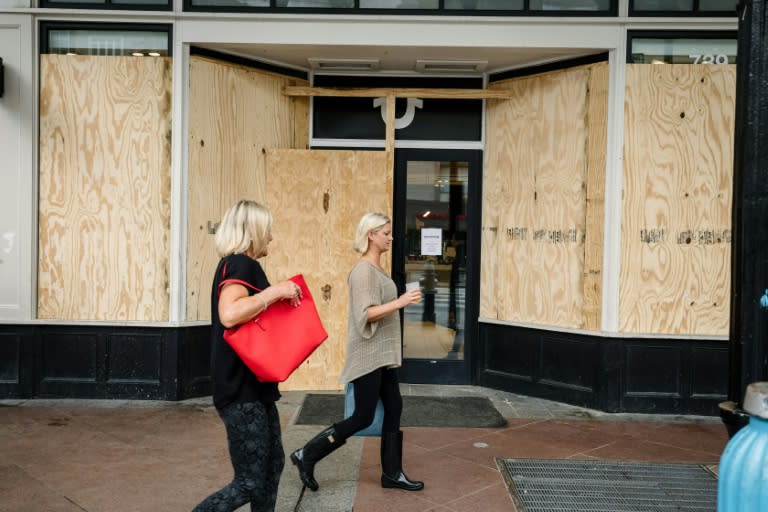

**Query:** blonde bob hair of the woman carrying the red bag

left=213, top=199, right=272, bottom=258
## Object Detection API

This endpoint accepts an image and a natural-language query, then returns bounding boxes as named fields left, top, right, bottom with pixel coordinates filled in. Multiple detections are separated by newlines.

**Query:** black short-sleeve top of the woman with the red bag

left=211, top=254, right=280, bottom=409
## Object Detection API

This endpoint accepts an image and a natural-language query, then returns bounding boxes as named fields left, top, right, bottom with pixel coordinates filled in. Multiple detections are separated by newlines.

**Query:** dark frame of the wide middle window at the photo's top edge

left=182, top=0, right=619, bottom=18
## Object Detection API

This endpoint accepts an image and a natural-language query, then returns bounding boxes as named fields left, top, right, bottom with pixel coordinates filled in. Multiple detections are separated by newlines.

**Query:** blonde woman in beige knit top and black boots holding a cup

left=291, top=213, right=424, bottom=491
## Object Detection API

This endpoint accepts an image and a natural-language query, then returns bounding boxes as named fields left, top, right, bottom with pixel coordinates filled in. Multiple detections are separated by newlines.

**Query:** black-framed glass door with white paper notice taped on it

left=392, top=149, right=481, bottom=384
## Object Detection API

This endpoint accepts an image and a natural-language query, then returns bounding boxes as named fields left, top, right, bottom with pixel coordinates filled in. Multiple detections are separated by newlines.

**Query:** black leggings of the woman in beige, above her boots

left=336, top=368, right=403, bottom=440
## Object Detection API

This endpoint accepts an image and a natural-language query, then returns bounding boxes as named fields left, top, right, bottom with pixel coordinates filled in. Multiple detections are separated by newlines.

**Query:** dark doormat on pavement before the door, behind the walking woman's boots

left=296, top=393, right=507, bottom=428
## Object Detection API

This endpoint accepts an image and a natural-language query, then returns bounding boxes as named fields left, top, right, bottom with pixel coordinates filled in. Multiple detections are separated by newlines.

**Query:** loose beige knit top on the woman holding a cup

left=339, top=260, right=403, bottom=384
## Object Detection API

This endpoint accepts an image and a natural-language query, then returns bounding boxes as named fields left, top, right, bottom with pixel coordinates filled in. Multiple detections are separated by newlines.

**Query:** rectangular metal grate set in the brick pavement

left=496, top=459, right=717, bottom=512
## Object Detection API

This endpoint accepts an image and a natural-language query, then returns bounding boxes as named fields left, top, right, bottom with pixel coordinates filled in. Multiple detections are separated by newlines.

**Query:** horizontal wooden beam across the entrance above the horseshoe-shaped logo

left=283, top=86, right=511, bottom=100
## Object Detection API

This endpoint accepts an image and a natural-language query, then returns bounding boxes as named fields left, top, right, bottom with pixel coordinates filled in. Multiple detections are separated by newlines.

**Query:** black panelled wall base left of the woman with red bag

left=0, top=325, right=211, bottom=400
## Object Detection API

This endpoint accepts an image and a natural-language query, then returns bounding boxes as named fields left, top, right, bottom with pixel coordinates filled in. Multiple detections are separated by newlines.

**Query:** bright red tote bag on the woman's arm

left=219, top=274, right=328, bottom=382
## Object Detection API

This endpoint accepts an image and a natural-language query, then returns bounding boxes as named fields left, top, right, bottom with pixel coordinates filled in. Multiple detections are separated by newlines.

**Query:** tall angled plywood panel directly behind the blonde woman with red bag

left=186, top=56, right=309, bottom=320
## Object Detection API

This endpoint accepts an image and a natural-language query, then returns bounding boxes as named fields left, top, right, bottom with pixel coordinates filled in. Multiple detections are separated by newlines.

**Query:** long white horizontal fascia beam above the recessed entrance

left=180, top=15, right=622, bottom=49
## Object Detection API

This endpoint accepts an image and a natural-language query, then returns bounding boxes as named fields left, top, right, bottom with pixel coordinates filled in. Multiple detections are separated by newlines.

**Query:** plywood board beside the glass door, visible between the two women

left=265, top=150, right=392, bottom=390
